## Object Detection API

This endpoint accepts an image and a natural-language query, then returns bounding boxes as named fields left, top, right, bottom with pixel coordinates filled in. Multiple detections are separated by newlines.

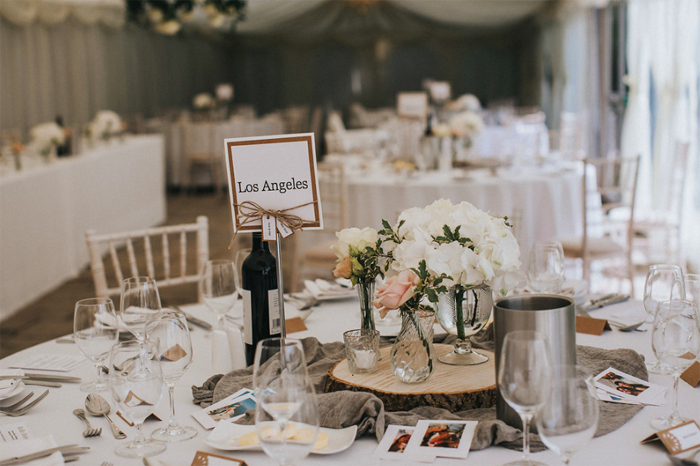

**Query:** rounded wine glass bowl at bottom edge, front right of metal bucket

left=536, top=375, right=598, bottom=464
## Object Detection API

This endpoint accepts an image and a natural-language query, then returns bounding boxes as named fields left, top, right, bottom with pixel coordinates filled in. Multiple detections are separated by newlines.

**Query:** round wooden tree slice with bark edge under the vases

left=325, top=345, right=496, bottom=412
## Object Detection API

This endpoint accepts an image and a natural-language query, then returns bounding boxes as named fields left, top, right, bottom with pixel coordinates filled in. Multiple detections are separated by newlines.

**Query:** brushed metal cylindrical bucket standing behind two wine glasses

left=493, top=295, right=576, bottom=429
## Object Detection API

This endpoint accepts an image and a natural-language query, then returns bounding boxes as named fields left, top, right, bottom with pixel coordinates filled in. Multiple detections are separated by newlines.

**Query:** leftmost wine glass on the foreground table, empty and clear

left=73, top=298, right=119, bottom=392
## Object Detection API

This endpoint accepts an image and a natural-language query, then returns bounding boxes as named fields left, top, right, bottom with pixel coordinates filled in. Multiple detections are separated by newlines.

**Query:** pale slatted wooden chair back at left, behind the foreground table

left=85, top=216, right=209, bottom=301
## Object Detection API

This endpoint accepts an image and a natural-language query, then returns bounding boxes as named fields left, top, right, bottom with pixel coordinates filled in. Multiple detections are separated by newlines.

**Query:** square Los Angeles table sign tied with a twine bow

left=224, top=133, right=323, bottom=241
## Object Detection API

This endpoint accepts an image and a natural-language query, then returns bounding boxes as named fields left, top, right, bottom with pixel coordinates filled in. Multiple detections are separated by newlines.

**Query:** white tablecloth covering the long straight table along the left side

left=0, top=135, right=166, bottom=319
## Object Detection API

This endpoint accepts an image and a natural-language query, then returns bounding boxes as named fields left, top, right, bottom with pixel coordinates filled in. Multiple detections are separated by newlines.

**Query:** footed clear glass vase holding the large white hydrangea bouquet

left=435, top=285, right=493, bottom=366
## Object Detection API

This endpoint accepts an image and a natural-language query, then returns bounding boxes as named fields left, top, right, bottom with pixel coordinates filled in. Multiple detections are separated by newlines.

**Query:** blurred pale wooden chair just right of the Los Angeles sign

left=298, top=162, right=347, bottom=286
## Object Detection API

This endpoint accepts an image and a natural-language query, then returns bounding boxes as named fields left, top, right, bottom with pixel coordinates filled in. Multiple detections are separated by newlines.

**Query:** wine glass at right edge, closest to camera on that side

left=651, top=299, right=700, bottom=430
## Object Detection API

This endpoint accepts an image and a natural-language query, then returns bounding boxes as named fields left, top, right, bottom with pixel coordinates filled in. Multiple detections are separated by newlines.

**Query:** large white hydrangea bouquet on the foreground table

left=379, top=199, right=524, bottom=301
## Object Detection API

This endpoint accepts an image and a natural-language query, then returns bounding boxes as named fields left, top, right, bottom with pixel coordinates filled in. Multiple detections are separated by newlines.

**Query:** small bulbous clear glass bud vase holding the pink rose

left=389, top=311, right=436, bottom=383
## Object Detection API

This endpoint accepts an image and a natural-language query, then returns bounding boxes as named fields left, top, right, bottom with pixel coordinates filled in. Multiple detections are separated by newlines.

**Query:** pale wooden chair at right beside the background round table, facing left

left=559, top=156, right=639, bottom=294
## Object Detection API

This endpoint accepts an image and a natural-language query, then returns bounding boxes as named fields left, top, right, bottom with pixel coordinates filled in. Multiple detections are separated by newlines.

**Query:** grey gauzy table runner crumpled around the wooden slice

left=192, top=325, right=648, bottom=451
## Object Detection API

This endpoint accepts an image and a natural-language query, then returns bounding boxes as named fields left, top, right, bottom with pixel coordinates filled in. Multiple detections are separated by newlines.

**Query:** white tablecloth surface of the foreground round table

left=0, top=298, right=700, bottom=466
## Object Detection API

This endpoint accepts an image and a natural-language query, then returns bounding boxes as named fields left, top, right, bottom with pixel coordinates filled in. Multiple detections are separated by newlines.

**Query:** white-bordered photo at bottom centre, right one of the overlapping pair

left=405, top=420, right=477, bottom=458
